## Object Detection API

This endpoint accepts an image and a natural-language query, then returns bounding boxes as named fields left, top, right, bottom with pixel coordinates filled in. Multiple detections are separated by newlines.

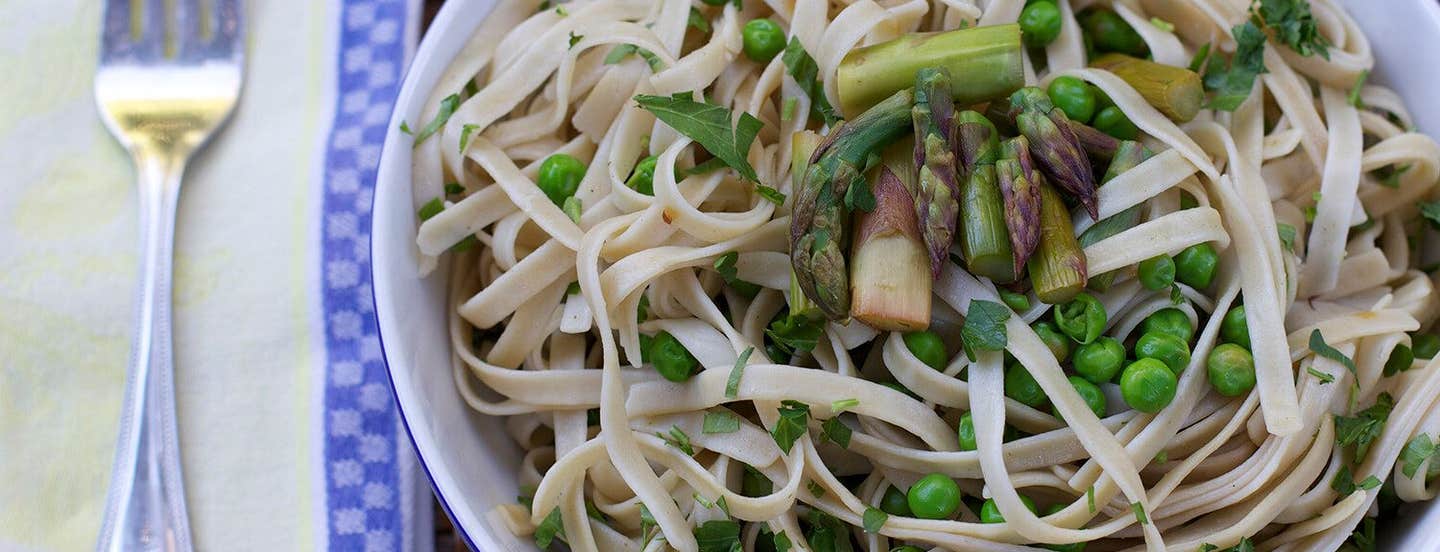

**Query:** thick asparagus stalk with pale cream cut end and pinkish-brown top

left=850, top=166, right=930, bottom=331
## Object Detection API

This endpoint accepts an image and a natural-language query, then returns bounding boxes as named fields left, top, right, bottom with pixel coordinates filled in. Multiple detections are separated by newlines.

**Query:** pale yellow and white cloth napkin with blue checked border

left=0, top=0, right=433, bottom=552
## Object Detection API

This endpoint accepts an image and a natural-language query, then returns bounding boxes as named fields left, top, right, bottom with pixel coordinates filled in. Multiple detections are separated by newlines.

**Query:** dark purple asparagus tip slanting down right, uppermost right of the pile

left=1009, top=86, right=1100, bottom=219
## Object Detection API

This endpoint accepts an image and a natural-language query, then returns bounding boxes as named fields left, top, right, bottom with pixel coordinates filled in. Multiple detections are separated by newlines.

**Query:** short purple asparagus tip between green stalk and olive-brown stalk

left=996, top=135, right=1043, bottom=277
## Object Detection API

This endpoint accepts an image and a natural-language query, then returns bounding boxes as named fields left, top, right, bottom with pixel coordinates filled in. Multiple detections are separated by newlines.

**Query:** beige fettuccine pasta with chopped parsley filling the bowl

left=410, top=0, right=1440, bottom=552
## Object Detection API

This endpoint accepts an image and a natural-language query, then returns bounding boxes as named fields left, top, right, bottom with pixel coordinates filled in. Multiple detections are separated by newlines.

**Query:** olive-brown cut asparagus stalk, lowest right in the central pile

left=1030, top=179, right=1086, bottom=304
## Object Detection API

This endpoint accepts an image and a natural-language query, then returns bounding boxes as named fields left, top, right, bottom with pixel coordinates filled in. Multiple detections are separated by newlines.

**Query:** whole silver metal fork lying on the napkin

left=95, top=0, right=245, bottom=552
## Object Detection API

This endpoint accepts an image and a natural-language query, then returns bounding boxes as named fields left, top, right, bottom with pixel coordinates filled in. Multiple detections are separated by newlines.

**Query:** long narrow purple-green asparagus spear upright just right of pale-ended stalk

left=910, top=68, right=960, bottom=278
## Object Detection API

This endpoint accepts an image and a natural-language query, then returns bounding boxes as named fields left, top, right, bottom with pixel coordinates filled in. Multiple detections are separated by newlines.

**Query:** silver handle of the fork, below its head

left=96, top=148, right=192, bottom=552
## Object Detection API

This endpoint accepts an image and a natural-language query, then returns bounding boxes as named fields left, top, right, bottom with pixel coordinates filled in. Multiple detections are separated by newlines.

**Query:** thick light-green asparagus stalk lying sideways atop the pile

left=835, top=23, right=1025, bottom=115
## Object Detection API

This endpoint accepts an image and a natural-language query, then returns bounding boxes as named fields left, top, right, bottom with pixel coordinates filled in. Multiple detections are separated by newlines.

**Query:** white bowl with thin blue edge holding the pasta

left=370, top=0, right=1440, bottom=551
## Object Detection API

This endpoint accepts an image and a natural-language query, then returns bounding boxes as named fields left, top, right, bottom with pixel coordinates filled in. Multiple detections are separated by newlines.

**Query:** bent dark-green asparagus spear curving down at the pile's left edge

left=791, top=89, right=913, bottom=320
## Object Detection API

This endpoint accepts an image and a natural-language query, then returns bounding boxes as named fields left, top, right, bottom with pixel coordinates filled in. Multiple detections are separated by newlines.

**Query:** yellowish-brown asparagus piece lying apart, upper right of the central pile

left=1090, top=53, right=1205, bottom=123
